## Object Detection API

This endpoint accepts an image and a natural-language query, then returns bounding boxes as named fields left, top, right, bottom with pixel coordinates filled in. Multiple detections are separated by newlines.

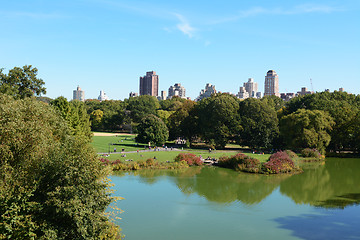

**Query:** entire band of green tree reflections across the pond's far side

left=116, top=159, right=360, bottom=208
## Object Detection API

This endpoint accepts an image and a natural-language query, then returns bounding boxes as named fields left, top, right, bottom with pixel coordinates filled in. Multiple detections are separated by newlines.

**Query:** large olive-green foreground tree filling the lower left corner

left=0, top=94, right=119, bottom=239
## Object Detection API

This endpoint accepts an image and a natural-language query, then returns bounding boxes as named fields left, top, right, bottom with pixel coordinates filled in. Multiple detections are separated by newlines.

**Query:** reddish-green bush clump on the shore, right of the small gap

left=218, top=151, right=303, bottom=174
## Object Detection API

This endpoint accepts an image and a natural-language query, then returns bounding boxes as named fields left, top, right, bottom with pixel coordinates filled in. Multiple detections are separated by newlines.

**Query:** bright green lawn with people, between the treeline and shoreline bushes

left=92, top=134, right=270, bottom=162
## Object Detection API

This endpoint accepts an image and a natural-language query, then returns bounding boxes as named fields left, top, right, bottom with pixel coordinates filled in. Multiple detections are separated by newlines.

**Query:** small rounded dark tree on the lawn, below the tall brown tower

left=135, top=115, right=169, bottom=146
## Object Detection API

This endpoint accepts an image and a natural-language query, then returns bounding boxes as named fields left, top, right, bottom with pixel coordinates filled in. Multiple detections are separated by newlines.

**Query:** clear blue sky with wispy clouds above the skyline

left=0, top=0, right=360, bottom=100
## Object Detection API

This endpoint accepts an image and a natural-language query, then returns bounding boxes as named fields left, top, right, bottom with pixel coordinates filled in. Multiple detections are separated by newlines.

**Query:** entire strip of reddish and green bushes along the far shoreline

left=100, top=148, right=325, bottom=175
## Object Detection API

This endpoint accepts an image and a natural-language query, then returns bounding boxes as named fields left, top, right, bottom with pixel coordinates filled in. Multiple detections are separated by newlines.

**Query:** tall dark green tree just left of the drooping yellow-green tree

left=239, top=98, right=279, bottom=149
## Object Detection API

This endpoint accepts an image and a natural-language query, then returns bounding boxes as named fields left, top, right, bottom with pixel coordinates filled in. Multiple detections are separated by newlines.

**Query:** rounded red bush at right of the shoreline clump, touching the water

left=262, top=151, right=299, bottom=174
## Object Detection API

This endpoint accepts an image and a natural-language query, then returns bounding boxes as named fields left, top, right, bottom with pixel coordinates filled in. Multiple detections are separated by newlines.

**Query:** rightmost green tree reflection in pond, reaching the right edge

left=280, top=159, right=360, bottom=208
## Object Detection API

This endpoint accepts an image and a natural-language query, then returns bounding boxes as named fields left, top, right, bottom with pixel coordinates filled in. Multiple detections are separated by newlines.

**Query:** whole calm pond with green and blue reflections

left=111, top=158, right=360, bottom=240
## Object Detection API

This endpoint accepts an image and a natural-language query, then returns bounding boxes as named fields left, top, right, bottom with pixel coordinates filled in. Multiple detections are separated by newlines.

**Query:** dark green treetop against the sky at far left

left=0, top=65, right=46, bottom=99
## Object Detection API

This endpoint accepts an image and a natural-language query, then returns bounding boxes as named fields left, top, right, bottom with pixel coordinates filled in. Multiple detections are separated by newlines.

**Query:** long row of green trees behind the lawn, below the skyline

left=85, top=91, right=360, bottom=155
